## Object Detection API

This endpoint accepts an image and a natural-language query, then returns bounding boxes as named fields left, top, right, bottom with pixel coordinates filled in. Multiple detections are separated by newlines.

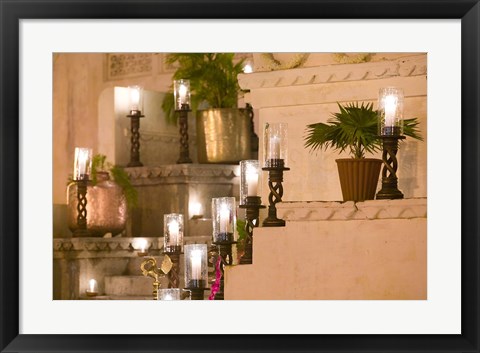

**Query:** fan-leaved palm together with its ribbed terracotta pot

left=304, top=102, right=422, bottom=201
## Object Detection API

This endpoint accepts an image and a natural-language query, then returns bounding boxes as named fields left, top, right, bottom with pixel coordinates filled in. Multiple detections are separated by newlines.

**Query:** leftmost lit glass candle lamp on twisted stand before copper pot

left=73, top=147, right=92, bottom=237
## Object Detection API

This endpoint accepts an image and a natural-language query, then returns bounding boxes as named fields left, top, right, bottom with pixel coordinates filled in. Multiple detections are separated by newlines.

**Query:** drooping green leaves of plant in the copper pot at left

left=92, top=154, right=138, bottom=208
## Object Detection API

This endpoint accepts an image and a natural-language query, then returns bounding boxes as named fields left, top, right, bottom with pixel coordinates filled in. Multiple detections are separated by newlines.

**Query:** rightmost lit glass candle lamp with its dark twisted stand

left=376, top=87, right=405, bottom=199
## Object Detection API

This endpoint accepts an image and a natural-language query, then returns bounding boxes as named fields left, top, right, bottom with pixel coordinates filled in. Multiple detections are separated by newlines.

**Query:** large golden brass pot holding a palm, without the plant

left=196, top=108, right=252, bottom=164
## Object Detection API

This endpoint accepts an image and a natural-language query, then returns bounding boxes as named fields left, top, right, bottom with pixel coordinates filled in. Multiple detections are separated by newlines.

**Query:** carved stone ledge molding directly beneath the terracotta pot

left=277, top=198, right=427, bottom=222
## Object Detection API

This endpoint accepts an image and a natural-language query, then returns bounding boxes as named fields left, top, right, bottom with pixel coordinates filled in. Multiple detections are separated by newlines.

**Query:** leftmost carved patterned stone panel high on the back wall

left=106, top=53, right=153, bottom=80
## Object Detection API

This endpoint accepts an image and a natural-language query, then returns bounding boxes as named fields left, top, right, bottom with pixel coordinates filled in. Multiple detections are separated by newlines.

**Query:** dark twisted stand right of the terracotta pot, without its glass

left=375, top=135, right=405, bottom=200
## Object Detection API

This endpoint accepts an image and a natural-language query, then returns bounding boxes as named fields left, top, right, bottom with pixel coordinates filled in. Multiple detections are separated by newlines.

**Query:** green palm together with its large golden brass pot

left=162, top=53, right=251, bottom=163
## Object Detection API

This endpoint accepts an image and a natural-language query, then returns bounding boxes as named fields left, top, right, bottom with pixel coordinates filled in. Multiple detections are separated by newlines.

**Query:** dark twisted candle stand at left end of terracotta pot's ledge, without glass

left=262, top=159, right=290, bottom=227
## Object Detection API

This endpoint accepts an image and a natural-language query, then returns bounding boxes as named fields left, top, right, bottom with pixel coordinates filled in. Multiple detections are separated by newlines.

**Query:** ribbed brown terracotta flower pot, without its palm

left=335, top=158, right=383, bottom=201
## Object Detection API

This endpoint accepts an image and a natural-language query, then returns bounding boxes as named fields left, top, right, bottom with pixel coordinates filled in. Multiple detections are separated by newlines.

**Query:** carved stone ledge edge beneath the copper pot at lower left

left=53, top=236, right=212, bottom=259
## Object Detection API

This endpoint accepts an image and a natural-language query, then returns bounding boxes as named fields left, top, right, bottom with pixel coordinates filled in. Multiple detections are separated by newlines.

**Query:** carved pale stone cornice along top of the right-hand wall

left=238, top=55, right=427, bottom=90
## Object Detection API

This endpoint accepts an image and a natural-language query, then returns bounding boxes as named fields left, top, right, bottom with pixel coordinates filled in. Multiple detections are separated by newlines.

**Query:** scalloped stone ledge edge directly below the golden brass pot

left=125, top=164, right=240, bottom=185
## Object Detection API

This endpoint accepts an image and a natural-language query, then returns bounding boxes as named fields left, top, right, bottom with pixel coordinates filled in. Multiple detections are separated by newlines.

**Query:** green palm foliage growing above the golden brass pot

left=162, top=53, right=243, bottom=124
